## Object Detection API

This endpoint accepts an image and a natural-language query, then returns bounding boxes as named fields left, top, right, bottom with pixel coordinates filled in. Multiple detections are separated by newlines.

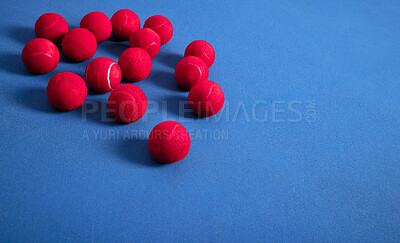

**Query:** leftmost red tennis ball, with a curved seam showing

left=21, top=38, right=60, bottom=74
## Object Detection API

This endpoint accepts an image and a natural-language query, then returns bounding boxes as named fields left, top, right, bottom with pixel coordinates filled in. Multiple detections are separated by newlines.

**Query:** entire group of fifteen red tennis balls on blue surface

left=22, top=9, right=225, bottom=163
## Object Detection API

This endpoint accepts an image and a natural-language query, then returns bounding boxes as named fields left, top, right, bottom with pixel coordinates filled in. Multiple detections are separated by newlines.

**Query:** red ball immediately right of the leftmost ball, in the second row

left=62, top=28, right=97, bottom=62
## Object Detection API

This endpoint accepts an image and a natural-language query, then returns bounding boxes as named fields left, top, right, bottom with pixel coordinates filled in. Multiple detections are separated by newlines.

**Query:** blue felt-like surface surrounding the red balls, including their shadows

left=0, top=0, right=400, bottom=242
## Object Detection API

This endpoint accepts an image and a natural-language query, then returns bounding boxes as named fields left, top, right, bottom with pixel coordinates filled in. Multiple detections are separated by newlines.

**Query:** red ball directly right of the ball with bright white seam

left=118, top=47, right=152, bottom=82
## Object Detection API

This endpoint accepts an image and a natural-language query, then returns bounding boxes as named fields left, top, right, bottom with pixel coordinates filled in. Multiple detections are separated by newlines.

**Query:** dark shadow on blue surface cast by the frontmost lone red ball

left=112, top=136, right=164, bottom=167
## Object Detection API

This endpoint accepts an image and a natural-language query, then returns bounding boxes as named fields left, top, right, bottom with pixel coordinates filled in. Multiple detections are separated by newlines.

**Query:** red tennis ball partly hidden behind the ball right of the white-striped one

left=129, top=28, right=161, bottom=58
